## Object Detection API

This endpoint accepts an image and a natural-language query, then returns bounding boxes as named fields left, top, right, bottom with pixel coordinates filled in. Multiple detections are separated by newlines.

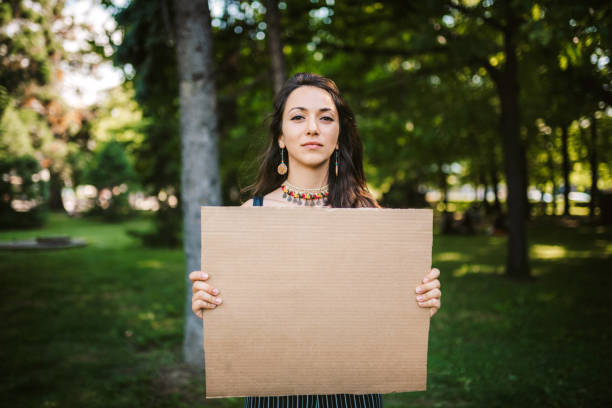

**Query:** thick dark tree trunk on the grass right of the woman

left=497, top=20, right=529, bottom=278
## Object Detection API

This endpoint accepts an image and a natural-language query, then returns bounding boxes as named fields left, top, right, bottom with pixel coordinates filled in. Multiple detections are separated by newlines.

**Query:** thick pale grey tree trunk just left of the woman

left=174, top=0, right=221, bottom=368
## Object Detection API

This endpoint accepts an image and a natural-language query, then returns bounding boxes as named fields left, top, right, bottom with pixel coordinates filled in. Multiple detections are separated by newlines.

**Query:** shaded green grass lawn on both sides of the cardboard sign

left=0, top=214, right=612, bottom=407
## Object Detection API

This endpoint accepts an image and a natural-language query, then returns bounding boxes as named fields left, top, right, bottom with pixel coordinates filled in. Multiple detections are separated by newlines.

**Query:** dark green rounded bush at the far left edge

left=0, top=156, right=49, bottom=229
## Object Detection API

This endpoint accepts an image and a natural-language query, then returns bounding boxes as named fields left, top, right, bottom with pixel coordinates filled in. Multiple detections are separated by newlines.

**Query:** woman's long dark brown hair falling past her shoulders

left=245, top=72, right=380, bottom=208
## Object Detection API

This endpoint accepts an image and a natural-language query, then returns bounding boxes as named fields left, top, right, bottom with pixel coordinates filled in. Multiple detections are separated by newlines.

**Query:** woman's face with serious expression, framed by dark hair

left=278, top=86, right=340, bottom=168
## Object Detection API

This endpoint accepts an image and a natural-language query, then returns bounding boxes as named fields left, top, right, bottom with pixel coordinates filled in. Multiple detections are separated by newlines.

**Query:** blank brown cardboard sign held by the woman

left=202, top=207, right=432, bottom=398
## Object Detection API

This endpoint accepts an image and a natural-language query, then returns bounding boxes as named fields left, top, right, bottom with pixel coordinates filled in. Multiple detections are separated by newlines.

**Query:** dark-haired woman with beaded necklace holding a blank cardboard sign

left=189, top=73, right=441, bottom=407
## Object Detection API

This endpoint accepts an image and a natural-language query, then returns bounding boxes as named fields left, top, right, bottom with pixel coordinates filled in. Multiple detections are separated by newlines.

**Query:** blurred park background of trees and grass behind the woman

left=0, top=0, right=612, bottom=407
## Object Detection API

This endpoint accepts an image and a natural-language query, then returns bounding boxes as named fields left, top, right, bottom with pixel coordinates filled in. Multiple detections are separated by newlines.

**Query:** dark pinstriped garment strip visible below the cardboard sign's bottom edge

left=244, top=394, right=383, bottom=408
